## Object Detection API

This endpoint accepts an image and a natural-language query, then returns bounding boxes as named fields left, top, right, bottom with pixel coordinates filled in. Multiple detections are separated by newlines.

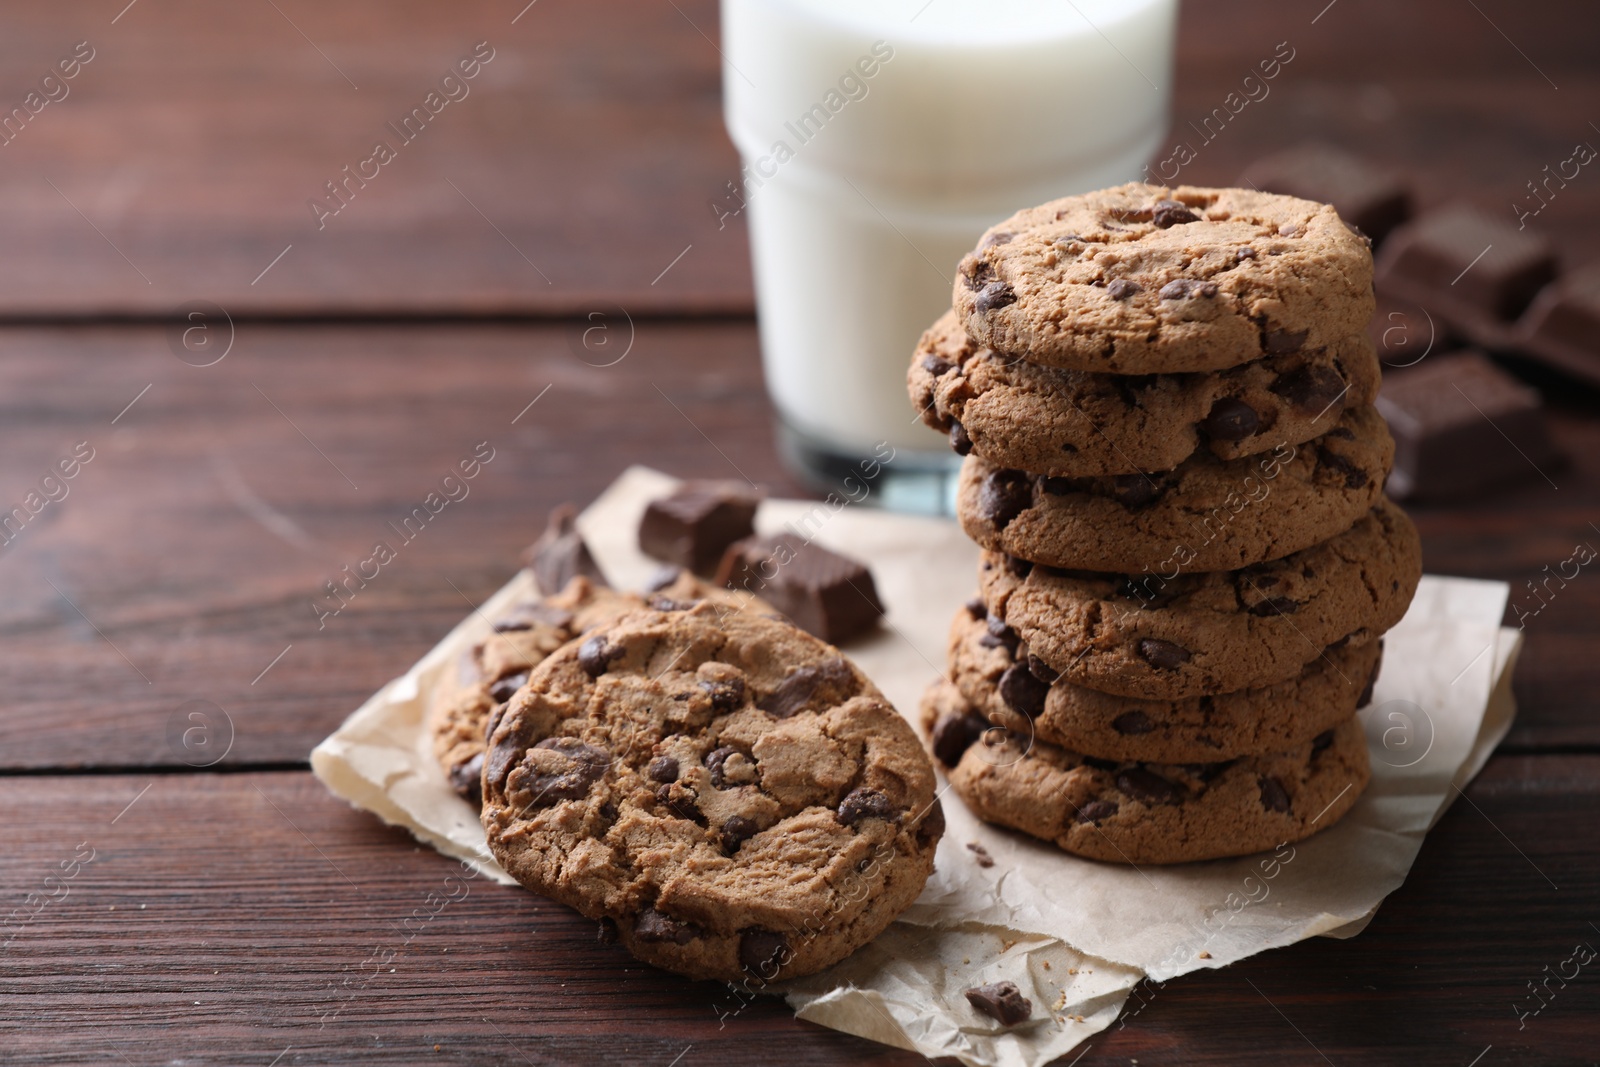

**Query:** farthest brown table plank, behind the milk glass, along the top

left=0, top=0, right=1600, bottom=318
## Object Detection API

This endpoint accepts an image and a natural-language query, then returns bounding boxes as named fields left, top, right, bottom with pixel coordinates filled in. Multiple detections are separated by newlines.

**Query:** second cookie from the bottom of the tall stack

left=936, top=601, right=1382, bottom=763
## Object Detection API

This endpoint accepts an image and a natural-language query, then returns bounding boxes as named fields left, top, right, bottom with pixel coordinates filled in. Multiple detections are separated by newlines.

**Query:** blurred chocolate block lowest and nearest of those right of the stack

left=1378, top=350, right=1560, bottom=501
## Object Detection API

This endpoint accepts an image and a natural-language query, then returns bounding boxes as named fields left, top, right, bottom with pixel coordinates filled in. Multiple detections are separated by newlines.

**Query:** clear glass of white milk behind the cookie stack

left=714, top=0, right=1178, bottom=510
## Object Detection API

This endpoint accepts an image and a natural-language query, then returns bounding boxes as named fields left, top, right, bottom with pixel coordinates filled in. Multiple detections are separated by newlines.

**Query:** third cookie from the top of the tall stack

left=955, top=406, right=1395, bottom=574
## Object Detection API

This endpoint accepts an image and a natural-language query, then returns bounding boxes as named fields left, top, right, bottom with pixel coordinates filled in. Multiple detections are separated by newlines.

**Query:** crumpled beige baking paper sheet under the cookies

left=312, top=467, right=1520, bottom=1067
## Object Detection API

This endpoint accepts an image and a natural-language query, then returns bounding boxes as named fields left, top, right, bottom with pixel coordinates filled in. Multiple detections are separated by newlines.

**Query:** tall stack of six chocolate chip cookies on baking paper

left=909, top=184, right=1421, bottom=864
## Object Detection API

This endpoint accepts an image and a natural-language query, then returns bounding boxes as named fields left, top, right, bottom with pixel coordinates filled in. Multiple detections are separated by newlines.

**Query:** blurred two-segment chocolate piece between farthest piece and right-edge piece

left=1374, top=205, right=1555, bottom=329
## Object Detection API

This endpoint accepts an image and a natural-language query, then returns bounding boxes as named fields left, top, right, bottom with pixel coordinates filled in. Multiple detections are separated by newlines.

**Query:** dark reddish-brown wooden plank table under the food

left=0, top=0, right=1600, bottom=1067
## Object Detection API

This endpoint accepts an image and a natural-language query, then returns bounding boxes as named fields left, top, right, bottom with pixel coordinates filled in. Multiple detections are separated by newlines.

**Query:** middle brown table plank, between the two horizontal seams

left=0, top=323, right=1600, bottom=768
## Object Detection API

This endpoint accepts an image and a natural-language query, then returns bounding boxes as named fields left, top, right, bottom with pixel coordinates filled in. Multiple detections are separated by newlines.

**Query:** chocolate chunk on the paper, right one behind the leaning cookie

left=717, top=534, right=883, bottom=645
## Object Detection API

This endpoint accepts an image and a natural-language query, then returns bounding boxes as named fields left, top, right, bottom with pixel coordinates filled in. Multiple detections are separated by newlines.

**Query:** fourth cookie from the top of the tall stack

left=978, top=499, right=1422, bottom=701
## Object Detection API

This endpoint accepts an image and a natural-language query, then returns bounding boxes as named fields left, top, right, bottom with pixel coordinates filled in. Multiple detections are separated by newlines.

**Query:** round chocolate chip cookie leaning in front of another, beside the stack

left=483, top=603, right=944, bottom=981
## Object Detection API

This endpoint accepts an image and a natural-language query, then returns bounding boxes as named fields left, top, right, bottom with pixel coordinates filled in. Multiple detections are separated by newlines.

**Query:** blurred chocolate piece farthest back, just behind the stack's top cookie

left=1238, top=142, right=1411, bottom=245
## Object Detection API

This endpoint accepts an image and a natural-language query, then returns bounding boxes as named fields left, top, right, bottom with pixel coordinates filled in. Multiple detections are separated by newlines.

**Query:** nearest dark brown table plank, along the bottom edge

left=0, top=757, right=1600, bottom=1067
